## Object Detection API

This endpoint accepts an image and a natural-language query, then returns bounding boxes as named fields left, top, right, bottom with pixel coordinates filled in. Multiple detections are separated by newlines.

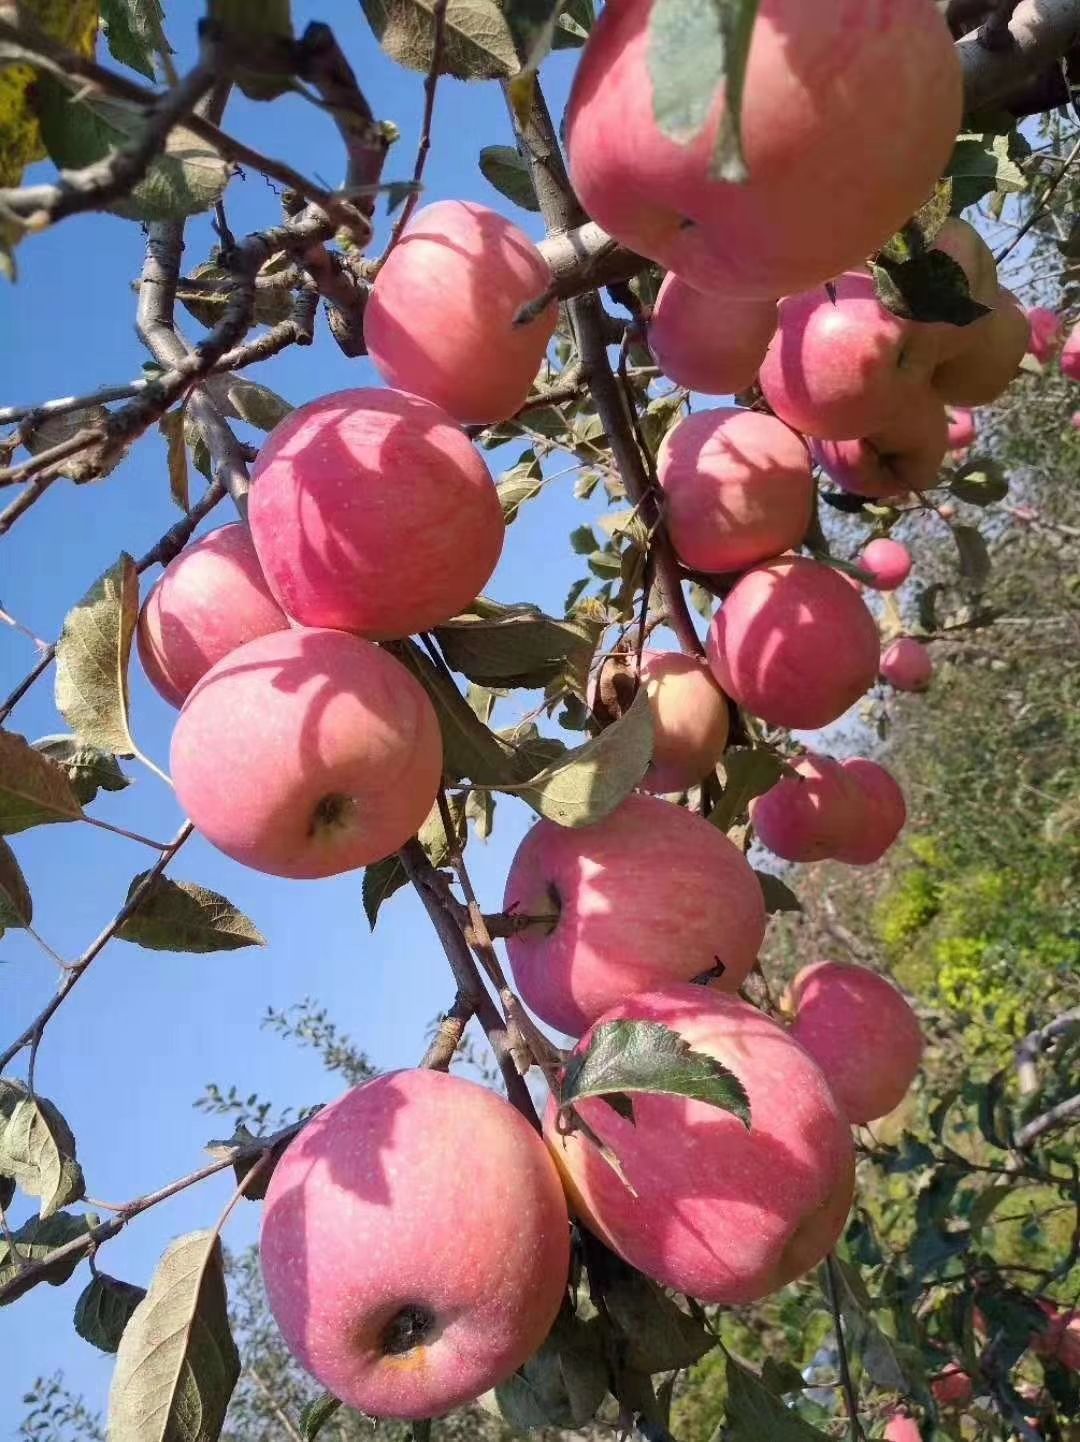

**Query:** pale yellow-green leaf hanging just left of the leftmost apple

left=56, top=552, right=138, bottom=756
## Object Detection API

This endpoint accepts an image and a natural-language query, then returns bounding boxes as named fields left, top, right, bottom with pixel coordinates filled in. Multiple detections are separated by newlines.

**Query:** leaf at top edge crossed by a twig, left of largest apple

left=360, top=0, right=521, bottom=81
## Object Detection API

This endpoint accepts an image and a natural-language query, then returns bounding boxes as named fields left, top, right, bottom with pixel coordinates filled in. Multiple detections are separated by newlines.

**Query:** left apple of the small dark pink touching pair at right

left=750, top=754, right=864, bottom=861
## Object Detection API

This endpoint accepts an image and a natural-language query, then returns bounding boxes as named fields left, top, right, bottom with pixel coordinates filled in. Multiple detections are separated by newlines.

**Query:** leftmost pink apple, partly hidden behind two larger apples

left=136, top=522, right=288, bottom=707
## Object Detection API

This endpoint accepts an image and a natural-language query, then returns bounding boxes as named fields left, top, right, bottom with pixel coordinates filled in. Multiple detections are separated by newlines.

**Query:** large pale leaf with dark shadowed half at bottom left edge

left=108, top=1231, right=239, bottom=1442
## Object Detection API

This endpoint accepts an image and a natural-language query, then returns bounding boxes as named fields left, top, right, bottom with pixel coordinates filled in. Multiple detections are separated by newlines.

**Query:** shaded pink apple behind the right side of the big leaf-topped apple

left=786, top=962, right=923, bottom=1125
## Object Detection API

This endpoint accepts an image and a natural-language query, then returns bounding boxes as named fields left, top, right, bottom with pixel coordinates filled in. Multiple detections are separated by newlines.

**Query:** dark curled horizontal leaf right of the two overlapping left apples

left=435, top=596, right=601, bottom=695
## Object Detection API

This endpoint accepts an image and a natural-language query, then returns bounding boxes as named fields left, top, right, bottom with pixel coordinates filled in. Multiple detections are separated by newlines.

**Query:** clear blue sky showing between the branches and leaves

left=0, top=0, right=596, bottom=1418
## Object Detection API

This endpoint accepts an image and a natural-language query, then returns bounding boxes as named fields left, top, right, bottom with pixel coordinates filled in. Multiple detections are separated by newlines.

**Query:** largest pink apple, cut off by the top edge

left=567, top=0, right=962, bottom=298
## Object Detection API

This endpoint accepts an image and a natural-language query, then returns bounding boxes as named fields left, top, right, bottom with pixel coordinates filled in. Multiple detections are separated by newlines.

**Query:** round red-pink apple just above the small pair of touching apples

left=708, top=557, right=880, bottom=731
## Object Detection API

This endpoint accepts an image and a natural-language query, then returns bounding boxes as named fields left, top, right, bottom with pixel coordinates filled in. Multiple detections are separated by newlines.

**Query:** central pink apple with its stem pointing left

left=503, top=795, right=766, bottom=1037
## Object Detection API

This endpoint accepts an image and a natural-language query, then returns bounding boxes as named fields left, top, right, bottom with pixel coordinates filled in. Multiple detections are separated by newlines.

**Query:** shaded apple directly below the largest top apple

left=649, top=271, right=776, bottom=395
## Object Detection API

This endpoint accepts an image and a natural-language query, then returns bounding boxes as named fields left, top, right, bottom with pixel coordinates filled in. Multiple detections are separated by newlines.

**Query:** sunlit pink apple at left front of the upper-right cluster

left=760, top=271, right=937, bottom=440
